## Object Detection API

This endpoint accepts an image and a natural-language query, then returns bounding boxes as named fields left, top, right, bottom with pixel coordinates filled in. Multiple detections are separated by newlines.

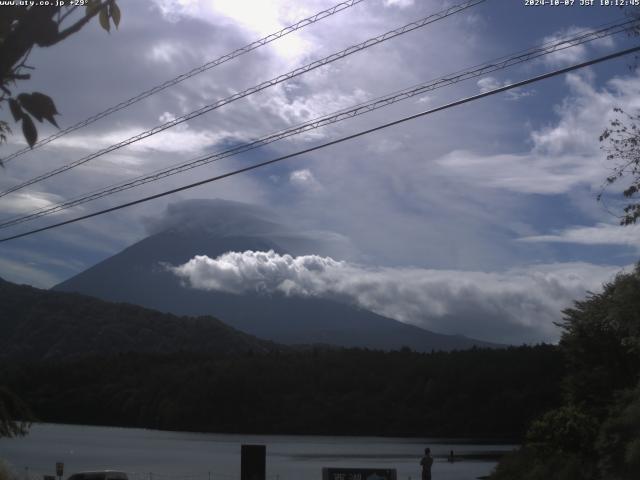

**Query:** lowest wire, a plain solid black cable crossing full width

left=0, top=47, right=640, bottom=243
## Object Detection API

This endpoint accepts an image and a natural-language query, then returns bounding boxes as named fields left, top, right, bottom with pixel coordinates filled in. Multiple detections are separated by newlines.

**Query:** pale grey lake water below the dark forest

left=0, top=424, right=514, bottom=480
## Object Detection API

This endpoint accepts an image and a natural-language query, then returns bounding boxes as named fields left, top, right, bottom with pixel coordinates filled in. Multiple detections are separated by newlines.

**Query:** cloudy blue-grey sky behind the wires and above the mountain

left=0, top=0, right=640, bottom=343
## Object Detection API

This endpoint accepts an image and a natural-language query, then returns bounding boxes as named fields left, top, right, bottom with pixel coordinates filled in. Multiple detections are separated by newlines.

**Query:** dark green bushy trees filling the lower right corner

left=491, top=263, right=640, bottom=480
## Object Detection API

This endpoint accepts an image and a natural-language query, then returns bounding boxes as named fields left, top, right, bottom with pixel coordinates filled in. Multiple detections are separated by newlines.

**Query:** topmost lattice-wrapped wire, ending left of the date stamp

left=0, top=0, right=364, bottom=164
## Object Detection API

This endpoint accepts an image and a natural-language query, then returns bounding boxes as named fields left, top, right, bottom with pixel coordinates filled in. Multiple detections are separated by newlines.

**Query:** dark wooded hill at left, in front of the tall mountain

left=0, top=279, right=282, bottom=360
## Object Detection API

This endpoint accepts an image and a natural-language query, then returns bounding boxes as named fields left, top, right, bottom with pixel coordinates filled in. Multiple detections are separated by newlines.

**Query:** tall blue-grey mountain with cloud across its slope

left=54, top=197, right=500, bottom=351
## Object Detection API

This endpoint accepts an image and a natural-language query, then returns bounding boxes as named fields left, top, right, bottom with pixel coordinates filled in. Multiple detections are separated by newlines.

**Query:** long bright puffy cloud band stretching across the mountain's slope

left=167, top=250, right=620, bottom=342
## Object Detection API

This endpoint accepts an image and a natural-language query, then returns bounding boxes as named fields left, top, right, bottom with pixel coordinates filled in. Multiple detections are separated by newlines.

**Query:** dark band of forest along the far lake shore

left=0, top=345, right=563, bottom=437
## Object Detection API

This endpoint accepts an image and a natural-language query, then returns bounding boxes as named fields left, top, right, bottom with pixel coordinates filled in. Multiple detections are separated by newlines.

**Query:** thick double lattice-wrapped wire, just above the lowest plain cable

left=0, top=20, right=640, bottom=229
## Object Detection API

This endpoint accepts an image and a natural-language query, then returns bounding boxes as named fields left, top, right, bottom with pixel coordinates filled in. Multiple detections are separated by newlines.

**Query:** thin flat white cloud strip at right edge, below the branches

left=520, top=223, right=640, bottom=251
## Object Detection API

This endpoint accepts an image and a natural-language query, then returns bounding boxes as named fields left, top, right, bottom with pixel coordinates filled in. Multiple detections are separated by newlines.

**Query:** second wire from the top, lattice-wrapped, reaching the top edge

left=0, top=0, right=487, bottom=197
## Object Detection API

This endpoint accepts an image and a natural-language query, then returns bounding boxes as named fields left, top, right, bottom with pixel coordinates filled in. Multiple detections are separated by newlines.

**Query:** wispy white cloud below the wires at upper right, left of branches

left=437, top=70, right=640, bottom=195
